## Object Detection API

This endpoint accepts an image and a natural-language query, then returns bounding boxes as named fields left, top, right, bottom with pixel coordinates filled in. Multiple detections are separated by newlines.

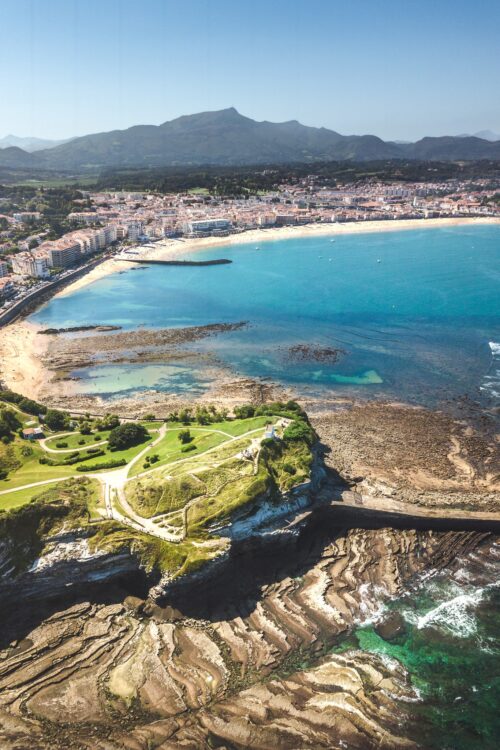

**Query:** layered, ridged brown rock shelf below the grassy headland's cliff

left=0, top=502, right=488, bottom=750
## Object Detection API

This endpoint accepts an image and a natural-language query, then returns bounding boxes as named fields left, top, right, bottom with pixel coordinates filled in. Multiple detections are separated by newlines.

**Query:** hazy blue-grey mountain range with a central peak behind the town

left=0, top=107, right=500, bottom=172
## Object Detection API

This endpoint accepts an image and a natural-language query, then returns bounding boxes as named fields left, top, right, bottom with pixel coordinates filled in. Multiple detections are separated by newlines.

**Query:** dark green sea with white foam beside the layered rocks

left=335, top=579, right=500, bottom=750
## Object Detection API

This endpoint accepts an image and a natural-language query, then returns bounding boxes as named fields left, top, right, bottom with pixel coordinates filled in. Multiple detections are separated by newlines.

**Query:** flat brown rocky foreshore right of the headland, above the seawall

left=312, top=402, right=500, bottom=512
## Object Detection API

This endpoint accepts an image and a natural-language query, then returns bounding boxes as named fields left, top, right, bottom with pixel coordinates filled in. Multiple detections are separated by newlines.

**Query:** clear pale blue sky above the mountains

left=0, top=0, right=500, bottom=139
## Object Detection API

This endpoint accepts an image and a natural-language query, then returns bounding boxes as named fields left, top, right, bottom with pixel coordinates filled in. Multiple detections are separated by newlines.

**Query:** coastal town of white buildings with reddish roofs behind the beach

left=0, top=175, right=500, bottom=318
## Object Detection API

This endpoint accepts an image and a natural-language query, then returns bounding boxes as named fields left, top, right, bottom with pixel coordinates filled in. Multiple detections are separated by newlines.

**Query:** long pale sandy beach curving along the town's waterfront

left=51, top=217, right=500, bottom=297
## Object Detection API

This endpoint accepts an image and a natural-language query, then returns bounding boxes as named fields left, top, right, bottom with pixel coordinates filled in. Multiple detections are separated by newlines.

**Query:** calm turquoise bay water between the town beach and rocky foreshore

left=32, top=226, right=500, bottom=403
